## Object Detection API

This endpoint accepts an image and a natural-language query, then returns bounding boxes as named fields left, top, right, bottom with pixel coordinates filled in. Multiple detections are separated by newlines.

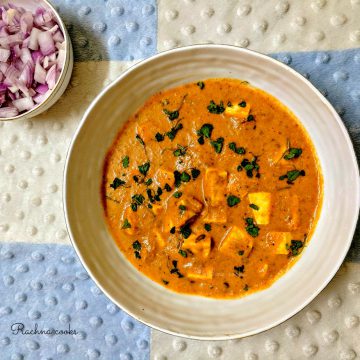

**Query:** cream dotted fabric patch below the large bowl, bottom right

left=151, top=263, right=360, bottom=360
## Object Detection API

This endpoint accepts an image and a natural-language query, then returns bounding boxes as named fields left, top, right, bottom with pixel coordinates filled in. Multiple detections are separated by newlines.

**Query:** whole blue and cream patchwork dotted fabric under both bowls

left=0, top=0, right=360, bottom=360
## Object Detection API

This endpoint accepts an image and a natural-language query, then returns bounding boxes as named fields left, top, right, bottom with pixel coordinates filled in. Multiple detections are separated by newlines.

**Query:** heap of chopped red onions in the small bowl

left=0, top=4, right=66, bottom=118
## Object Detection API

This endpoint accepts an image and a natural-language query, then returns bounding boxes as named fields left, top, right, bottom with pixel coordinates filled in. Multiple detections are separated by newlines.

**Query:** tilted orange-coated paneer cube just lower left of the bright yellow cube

left=219, top=226, right=254, bottom=256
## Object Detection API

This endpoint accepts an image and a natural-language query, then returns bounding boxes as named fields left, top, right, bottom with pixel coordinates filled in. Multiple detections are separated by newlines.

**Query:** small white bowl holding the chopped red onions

left=0, top=0, right=74, bottom=121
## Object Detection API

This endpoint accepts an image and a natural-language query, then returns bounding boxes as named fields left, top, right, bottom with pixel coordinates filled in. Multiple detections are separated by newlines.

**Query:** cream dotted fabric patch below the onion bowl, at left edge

left=0, top=61, right=131, bottom=243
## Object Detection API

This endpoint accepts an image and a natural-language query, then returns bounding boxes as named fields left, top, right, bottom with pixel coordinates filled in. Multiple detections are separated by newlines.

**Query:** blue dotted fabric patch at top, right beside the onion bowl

left=52, top=0, right=157, bottom=61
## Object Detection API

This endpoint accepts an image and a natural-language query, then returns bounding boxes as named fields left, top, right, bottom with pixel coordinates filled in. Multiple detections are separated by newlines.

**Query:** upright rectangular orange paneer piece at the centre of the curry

left=203, top=168, right=227, bottom=206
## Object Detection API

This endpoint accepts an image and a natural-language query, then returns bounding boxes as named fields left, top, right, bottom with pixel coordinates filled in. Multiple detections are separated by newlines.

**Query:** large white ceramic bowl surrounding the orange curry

left=64, top=45, right=360, bottom=340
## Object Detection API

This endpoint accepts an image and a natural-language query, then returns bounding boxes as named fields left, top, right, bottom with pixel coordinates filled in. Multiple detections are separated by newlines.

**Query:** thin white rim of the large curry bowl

left=63, top=44, right=360, bottom=340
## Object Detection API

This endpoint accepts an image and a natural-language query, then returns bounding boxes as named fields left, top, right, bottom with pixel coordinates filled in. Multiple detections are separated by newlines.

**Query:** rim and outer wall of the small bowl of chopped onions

left=0, top=0, right=73, bottom=121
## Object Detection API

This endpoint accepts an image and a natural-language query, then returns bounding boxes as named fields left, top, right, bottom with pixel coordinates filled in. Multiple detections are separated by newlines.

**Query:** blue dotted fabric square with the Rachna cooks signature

left=0, top=243, right=150, bottom=360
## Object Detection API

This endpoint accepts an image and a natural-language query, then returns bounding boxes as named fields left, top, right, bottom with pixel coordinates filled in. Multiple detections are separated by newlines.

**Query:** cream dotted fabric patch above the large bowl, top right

left=158, top=0, right=360, bottom=52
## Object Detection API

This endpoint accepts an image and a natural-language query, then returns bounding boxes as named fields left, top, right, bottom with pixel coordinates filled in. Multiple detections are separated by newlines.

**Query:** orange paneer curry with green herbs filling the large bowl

left=102, top=79, right=322, bottom=298
